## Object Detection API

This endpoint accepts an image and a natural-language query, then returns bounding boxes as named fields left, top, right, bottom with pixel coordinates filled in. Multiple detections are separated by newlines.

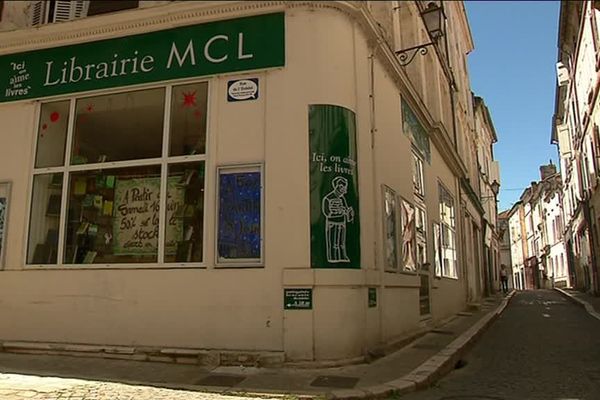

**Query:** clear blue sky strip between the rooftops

left=465, top=0, right=560, bottom=211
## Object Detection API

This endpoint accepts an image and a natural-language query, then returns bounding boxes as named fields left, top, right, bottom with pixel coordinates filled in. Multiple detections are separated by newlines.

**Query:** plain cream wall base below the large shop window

left=0, top=269, right=283, bottom=351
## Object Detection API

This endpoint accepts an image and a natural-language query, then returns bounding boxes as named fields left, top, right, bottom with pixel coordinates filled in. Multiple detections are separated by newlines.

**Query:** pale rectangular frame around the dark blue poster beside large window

left=214, top=163, right=265, bottom=269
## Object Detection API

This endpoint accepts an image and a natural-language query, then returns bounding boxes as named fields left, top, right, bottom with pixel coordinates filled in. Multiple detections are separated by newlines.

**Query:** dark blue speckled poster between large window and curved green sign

left=217, top=172, right=261, bottom=261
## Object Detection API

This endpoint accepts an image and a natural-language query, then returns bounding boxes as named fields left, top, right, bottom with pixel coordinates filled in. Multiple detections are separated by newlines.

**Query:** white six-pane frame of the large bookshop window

left=21, top=77, right=214, bottom=270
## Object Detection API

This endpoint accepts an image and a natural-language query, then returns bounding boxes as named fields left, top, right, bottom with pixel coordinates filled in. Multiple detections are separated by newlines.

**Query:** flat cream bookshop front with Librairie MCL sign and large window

left=0, top=11, right=298, bottom=362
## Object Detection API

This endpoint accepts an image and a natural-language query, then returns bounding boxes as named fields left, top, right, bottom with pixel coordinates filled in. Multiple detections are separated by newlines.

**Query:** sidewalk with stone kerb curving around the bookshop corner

left=0, top=291, right=515, bottom=400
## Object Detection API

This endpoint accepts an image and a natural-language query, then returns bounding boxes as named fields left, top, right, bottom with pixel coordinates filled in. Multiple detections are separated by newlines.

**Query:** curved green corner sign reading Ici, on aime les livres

left=309, top=105, right=360, bottom=268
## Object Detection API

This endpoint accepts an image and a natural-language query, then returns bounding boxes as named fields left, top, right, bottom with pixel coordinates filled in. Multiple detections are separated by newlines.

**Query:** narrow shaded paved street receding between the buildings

left=402, top=290, right=600, bottom=400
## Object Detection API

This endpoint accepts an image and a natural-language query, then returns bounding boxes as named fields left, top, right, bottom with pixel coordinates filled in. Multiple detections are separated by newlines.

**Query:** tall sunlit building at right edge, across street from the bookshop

left=551, top=1, right=600, bottom=294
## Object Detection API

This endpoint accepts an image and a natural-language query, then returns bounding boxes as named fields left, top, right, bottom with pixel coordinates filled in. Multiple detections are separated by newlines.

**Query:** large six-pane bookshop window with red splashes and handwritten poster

left=27, top=82, right=208, bottom=265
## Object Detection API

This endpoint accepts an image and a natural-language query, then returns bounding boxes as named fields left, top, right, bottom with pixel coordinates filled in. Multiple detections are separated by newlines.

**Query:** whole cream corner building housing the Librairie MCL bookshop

left=0, top=1, right=498, bottom=365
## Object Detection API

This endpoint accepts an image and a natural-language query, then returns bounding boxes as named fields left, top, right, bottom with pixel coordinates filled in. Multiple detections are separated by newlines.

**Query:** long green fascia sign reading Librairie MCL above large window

left=0, top=13, right=285, bottom=102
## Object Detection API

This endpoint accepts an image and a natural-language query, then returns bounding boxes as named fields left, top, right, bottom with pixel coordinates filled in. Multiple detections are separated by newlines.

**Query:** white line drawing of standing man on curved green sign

left=321, top=176, right=354, bottom=263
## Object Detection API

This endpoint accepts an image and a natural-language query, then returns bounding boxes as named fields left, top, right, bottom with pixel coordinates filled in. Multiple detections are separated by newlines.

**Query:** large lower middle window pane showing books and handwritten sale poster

left=64, top=165, right=160, bottom=264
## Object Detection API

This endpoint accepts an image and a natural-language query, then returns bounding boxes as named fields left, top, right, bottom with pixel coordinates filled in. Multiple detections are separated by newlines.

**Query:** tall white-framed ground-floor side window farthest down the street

left=439, top=185, right=458, bottom=278
